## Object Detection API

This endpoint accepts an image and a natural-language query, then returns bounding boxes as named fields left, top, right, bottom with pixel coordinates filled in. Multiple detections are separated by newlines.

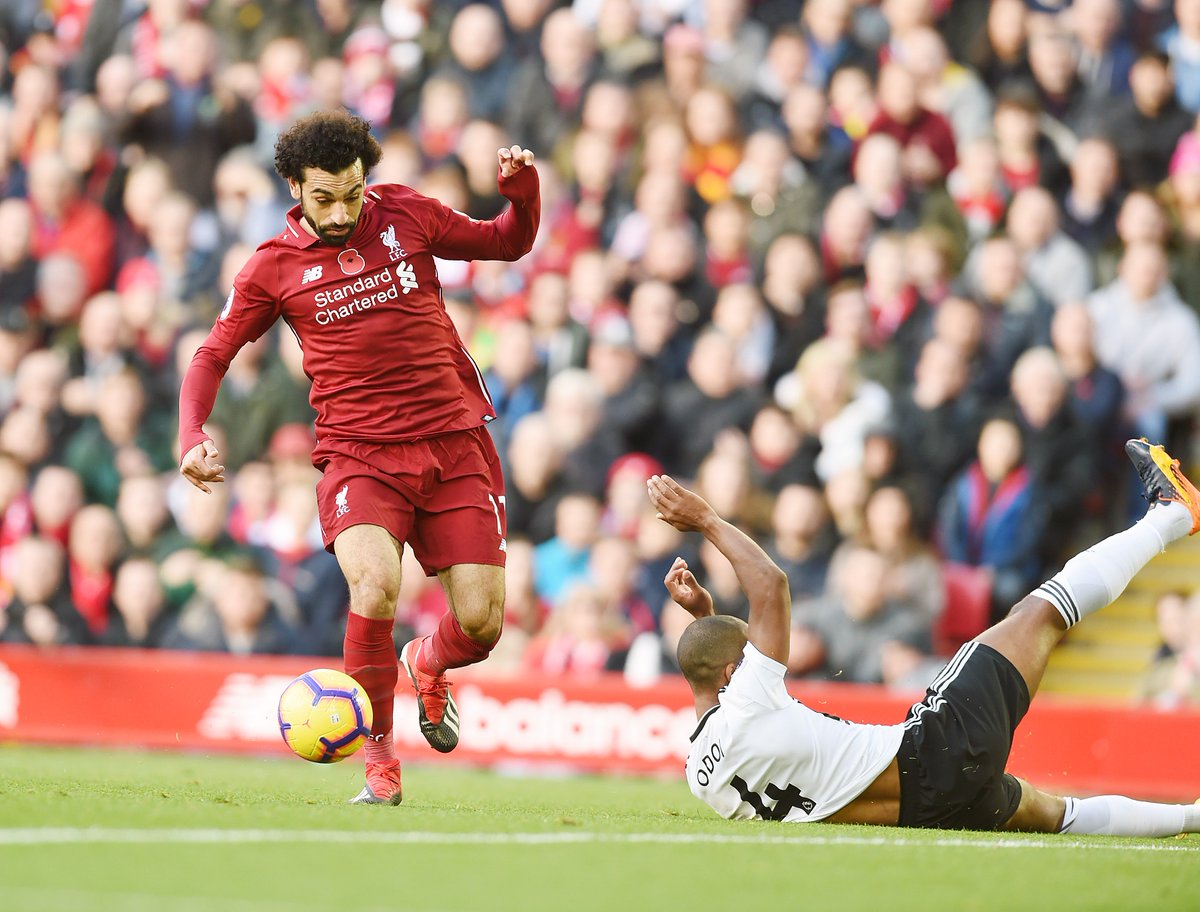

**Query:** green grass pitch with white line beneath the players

left=0, top=745, right=1200, bottom=912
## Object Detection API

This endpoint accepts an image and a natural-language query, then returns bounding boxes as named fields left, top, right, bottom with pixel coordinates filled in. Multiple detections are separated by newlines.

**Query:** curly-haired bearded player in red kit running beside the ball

left=179, top=113, right=541, bottom=804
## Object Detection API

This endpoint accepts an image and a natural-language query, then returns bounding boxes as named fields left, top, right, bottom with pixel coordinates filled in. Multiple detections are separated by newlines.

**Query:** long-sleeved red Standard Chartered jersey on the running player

left=179, top=168, right=541, bottom=454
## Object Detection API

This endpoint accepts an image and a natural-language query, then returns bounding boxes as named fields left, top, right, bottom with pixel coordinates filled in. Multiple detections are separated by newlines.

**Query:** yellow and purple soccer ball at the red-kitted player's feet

left=280, top=668, right=372, bottom=763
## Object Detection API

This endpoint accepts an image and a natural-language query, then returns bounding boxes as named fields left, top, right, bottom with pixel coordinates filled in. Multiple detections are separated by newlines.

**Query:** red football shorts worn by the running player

left=312, top=427, right=506, bottom=576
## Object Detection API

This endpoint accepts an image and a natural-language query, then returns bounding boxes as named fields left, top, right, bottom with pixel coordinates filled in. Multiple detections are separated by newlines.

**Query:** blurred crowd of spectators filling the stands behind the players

left=0, top=0, right=1200, bottom=686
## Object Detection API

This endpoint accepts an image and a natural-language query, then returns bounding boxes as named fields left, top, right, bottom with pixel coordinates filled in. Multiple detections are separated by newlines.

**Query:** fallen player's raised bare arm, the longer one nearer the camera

left=646, top=475, right=792, bottom=665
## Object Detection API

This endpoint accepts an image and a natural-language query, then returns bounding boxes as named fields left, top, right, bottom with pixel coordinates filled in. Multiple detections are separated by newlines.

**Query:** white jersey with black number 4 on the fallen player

left=686, top=643, right=904, bottom=823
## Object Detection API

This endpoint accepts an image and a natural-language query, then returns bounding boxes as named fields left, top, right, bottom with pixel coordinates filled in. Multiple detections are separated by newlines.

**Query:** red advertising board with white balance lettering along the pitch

left=0, top=647, right=1200, bottom=800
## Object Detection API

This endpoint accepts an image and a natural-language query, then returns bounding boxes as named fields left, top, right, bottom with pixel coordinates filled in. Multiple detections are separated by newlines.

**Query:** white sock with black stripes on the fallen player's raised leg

left=1033, top=503, right=1192, bottom=628
